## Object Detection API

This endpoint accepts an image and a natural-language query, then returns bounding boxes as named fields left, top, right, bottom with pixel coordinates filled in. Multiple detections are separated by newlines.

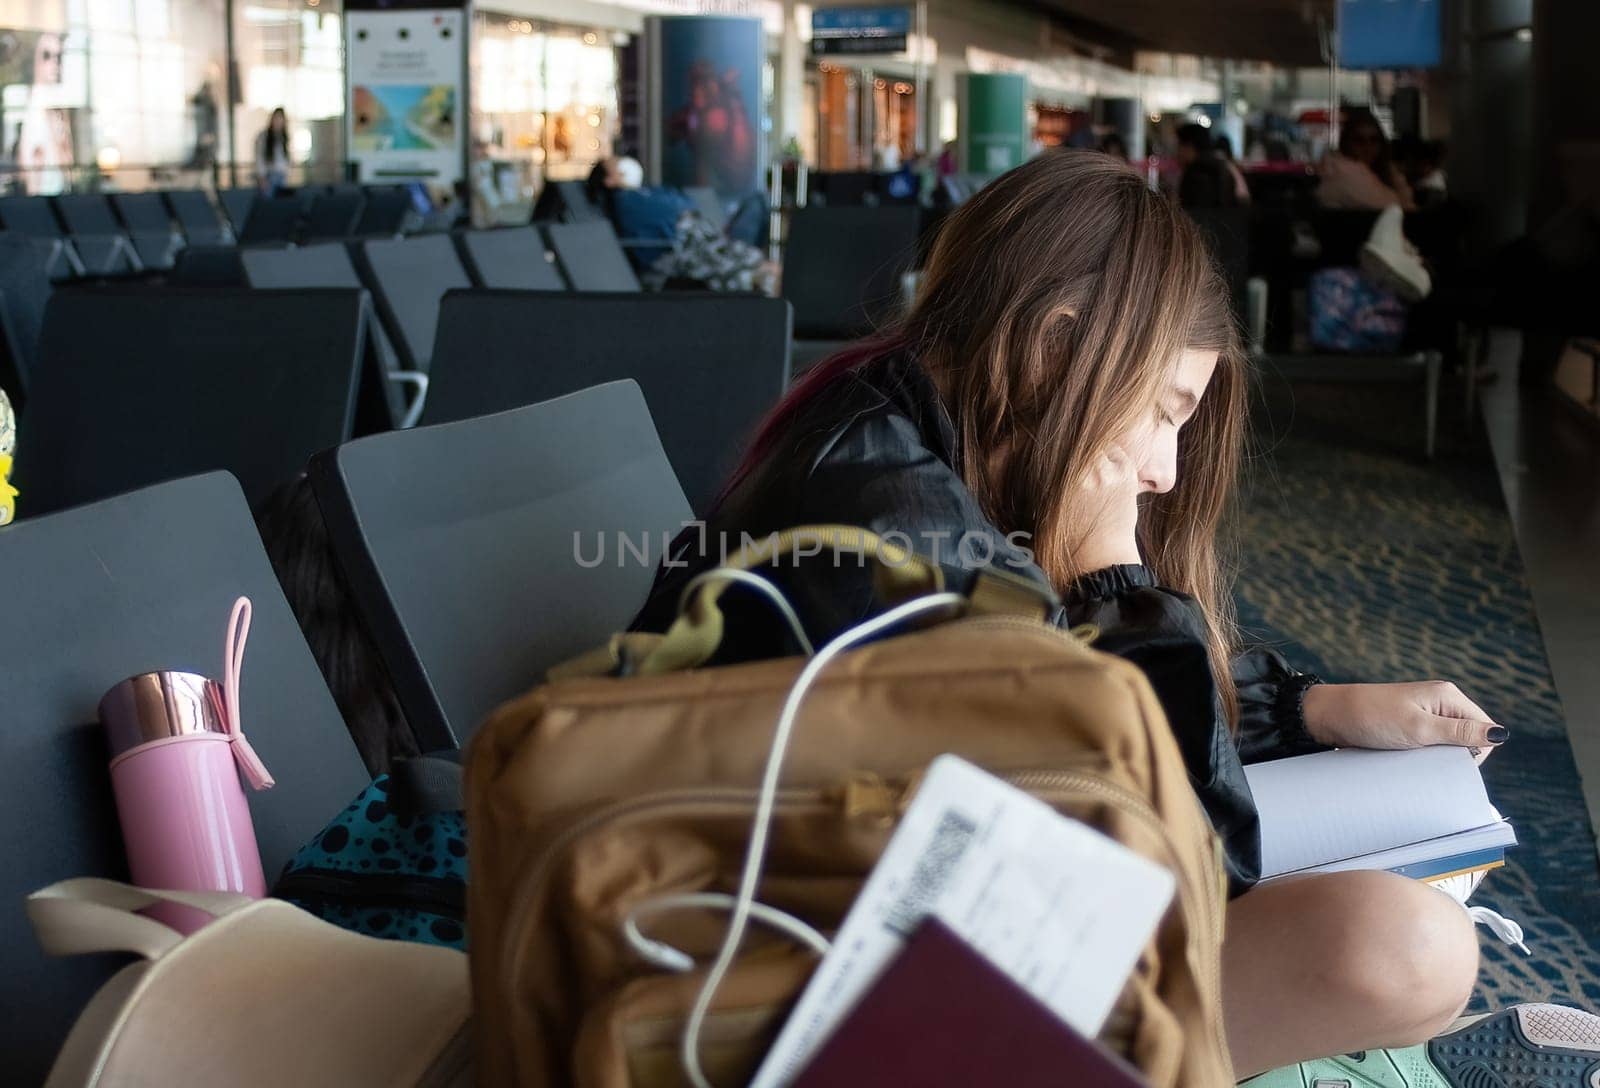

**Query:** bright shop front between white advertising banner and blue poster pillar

left=470, top=11, right=627, bottom=219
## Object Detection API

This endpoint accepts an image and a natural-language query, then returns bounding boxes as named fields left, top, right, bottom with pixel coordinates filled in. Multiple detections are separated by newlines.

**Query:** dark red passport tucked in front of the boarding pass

left=792, top=918, right=1146, bottom=1088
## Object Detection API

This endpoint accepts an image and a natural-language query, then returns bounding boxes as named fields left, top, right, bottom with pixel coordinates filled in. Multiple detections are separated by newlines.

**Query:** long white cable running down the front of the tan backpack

left=674, top=592, right=966, bottom=1088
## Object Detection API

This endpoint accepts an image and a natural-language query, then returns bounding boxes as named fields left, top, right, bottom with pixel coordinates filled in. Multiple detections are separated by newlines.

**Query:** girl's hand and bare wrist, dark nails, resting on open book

left=1304, top=680, right=1510, bottom=763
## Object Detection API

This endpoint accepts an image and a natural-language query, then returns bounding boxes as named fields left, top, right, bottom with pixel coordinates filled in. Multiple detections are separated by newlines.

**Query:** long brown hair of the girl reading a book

left=746, top=150, right=1246, bottom=722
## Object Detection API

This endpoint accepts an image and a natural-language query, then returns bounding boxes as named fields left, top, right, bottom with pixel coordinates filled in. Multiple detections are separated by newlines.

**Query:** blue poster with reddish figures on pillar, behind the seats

left=648, top=16, right=766, bottom=195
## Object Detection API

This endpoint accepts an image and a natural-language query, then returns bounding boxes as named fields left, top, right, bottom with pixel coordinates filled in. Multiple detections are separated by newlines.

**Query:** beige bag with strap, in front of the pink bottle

left=27, top=878, right=470, bottom=1088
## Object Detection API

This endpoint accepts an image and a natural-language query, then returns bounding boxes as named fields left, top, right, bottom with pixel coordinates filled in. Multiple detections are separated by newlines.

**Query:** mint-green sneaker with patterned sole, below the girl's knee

left=1243, top=1005, right=1600, bottom=1088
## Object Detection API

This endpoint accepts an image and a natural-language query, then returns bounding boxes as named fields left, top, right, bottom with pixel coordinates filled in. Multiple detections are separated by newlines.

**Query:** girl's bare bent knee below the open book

left=1222, top=872, right=1478, bottom=1078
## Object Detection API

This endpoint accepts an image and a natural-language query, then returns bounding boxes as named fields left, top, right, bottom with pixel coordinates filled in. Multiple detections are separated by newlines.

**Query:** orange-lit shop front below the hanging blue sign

left=812, top=61, right=917, bottom=171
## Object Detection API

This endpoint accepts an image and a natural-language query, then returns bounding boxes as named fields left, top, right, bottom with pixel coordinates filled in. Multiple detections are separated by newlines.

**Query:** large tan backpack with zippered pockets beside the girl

left=467, top=526, right=1234, bottom=1088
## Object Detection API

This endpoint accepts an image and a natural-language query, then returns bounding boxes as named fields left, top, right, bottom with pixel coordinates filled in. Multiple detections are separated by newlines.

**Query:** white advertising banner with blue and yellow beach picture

left=344, top=3, right=469, bottom=187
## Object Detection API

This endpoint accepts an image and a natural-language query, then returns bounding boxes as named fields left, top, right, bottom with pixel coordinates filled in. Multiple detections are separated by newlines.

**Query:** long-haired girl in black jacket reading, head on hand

left=638, top=152, right=1600, bottom=1086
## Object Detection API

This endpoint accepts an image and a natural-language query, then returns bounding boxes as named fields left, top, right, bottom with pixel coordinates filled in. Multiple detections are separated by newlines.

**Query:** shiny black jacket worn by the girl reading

left=635, top=360, right=1322, bottom=894
